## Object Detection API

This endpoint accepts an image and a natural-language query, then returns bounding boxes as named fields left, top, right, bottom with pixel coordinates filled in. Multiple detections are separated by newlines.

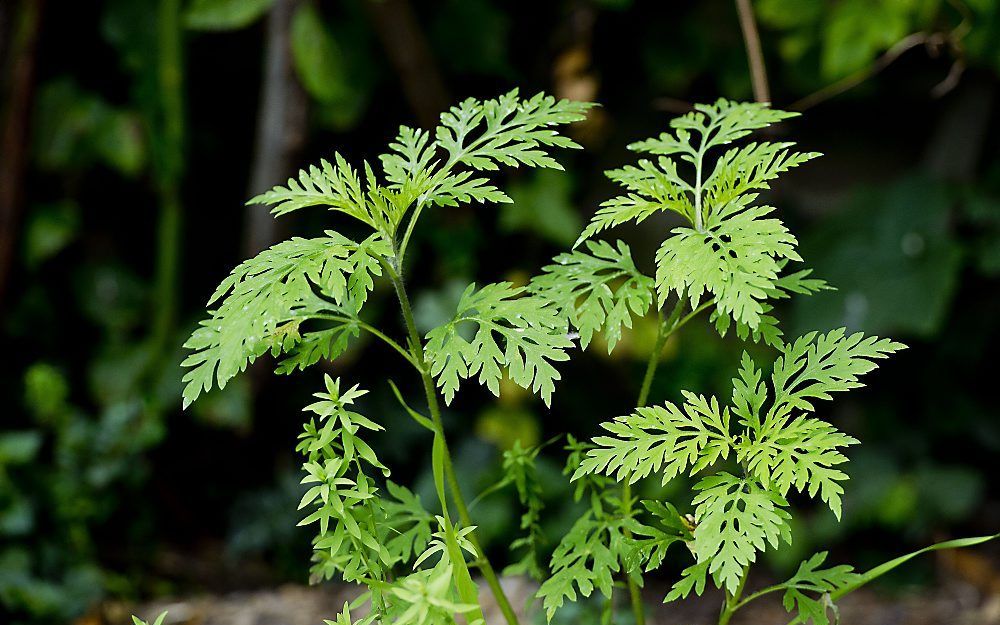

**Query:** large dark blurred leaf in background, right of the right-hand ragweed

left=793, top=178, right=961, bottom=336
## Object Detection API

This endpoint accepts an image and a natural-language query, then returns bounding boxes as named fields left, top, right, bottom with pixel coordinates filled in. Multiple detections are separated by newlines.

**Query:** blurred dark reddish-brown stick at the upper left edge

left=0, top=0, right=42, bottom=305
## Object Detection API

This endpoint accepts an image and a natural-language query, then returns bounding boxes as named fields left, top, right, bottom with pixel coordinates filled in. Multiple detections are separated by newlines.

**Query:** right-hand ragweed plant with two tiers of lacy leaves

left=529, top=100, right=988, bottom=625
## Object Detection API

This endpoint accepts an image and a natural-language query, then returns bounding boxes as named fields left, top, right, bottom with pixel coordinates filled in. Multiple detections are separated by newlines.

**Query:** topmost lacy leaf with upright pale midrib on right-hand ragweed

left=578, top=100, right=817, bottom=332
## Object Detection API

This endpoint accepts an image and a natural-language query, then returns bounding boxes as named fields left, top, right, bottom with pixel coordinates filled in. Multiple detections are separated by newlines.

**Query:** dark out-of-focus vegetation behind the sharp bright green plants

left=0, top=0, right=1000, bottom=623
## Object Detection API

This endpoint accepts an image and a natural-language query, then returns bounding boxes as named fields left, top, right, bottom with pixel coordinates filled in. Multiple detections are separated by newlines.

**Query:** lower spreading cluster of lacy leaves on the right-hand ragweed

left=574, top=330, right=903, bottom=599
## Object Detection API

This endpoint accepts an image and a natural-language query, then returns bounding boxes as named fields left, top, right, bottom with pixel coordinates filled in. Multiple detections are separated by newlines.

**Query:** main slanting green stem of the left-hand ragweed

left=385, top=260, right=518, bottom=625
